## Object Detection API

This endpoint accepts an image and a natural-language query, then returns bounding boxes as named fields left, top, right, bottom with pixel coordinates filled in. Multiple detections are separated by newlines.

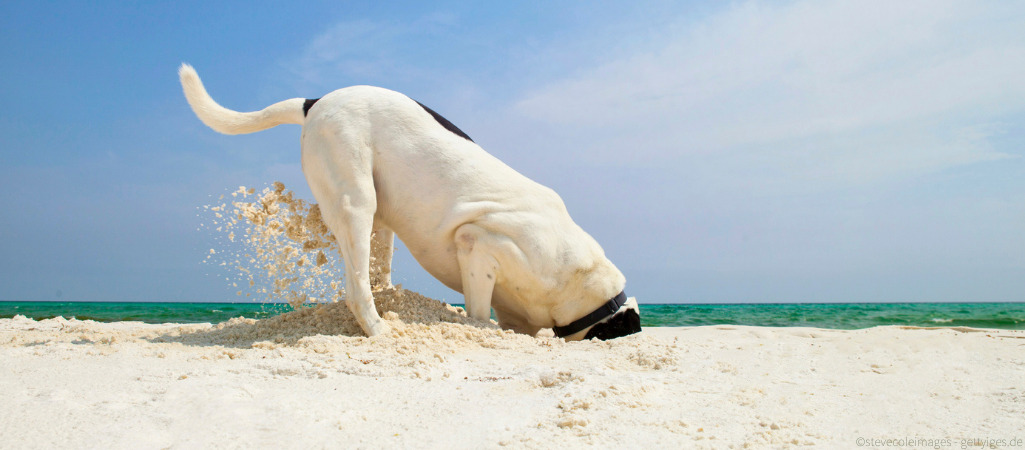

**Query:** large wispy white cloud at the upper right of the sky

left=516, top=0, right=1025, bottom=182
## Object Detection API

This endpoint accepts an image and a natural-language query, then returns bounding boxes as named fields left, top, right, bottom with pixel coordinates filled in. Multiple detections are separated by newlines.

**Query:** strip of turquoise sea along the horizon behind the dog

left=0, top=301, right=1025, bottom=329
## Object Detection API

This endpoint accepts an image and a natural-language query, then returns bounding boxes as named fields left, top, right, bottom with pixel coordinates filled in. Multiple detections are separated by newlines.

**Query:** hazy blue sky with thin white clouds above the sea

left=0, top=0, right=1025, bottom=302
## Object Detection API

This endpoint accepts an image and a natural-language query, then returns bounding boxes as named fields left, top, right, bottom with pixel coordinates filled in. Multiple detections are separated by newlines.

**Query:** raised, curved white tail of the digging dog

left=178, top=64, right=305, bottom=134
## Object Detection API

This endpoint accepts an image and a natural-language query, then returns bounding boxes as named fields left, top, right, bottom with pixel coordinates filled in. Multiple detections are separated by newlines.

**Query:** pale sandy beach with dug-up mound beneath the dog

left=0, top=295, right=1025, bottom=448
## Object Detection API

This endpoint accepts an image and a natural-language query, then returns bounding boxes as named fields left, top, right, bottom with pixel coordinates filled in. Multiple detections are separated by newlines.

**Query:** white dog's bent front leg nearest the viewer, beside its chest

left=455, top=223, right=498, bottom=320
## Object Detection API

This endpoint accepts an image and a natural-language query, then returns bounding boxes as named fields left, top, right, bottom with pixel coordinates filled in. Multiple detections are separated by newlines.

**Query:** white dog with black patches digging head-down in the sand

left=178, top=65, right=641, bottom=340
